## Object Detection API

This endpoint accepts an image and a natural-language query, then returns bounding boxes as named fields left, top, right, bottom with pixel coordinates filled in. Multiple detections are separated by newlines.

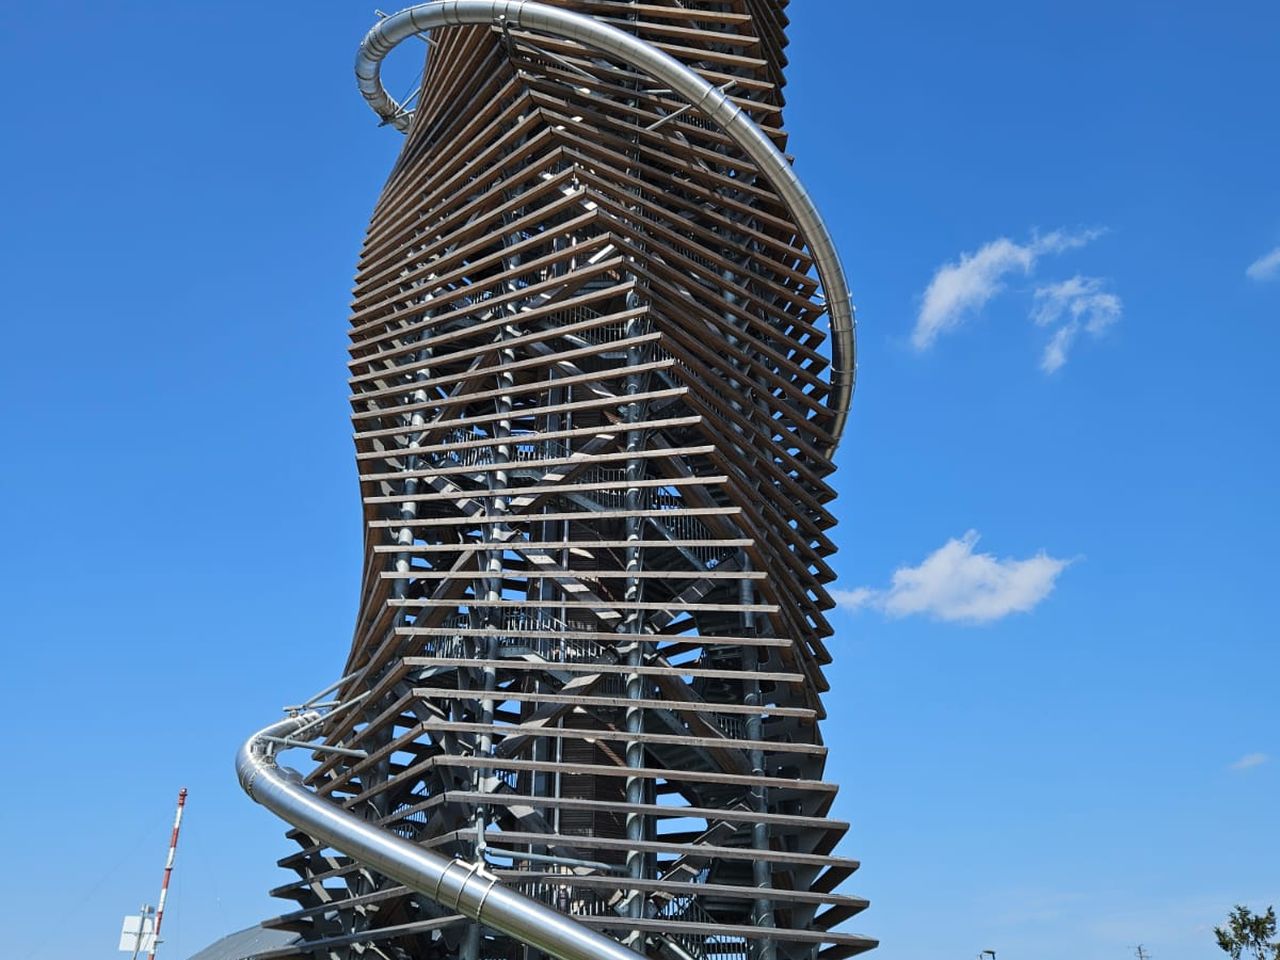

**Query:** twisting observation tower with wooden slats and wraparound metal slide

left=239, top=0, right=874, bottom=960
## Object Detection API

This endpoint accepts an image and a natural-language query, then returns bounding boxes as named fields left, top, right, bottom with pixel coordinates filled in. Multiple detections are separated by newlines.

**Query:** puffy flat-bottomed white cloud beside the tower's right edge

left=832, top=530, right=1069, bottom=623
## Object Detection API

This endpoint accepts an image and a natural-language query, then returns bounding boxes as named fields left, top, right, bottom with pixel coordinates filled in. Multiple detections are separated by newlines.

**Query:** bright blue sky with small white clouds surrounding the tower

left=0, top=0, right=1280, bottom=960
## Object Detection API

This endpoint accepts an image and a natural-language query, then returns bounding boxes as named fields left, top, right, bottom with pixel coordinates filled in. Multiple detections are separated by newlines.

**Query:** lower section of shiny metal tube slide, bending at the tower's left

left=236, top=713, right=641, bottom=960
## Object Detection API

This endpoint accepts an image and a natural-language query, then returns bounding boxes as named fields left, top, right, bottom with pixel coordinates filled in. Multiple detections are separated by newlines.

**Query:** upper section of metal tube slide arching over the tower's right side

left=356, top=0, right=858, bottom=456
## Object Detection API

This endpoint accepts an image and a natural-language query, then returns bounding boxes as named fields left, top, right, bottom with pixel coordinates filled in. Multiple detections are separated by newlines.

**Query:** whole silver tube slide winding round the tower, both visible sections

left=237, top=0, right=856, bottom=960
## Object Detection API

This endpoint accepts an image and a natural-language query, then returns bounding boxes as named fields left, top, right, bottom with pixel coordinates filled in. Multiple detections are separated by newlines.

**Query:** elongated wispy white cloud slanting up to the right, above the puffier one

left=911, top=230, right=1102, bottom=349
